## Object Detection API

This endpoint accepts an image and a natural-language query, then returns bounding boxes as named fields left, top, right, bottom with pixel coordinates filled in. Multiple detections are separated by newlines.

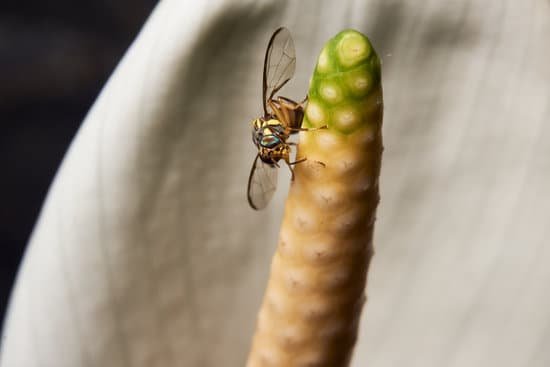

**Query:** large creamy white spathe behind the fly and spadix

left=0, top=0, right=550, bottom=367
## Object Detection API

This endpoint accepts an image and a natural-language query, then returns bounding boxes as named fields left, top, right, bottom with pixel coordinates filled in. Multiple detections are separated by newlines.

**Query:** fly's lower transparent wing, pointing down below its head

left=248, top=155, right=277, bottom=210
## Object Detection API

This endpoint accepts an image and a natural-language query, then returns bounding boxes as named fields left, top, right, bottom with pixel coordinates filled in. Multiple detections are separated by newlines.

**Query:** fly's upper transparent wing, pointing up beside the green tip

left=263, top=27, right=296, bottom=115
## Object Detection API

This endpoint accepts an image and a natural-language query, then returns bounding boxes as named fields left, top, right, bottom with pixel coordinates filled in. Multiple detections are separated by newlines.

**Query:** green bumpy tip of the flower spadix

left=304, top=29, right=382, bottom=134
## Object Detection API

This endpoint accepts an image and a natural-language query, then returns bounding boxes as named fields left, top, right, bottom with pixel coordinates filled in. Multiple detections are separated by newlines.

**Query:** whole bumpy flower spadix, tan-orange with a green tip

left=247, top=30, right=382, bottom=367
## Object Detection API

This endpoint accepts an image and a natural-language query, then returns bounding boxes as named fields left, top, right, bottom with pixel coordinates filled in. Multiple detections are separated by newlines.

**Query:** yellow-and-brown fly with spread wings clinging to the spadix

left=248, top=27, right=326, bottom=210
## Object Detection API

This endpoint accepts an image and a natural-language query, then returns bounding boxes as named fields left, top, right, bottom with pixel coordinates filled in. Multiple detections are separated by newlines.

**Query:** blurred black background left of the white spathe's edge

left=0, top=0, right=157, bottom=328
